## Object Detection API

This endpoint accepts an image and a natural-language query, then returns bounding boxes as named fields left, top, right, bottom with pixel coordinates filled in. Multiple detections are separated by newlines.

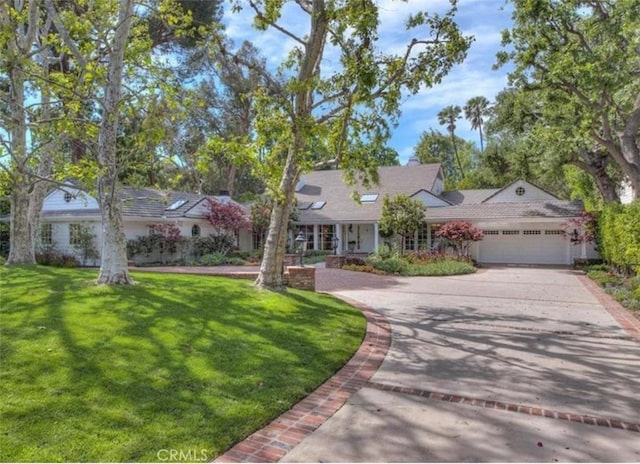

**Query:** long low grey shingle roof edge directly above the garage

left=427, top=200, right=583, bottom=222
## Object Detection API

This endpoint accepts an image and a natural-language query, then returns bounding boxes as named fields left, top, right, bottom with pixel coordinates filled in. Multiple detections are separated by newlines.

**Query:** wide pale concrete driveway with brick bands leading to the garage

left=282, top=267, right=640, bottom=462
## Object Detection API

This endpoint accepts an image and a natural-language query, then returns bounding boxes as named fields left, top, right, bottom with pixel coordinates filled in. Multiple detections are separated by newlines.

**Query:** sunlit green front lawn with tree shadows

left=0, top=267, right=366, bottom=462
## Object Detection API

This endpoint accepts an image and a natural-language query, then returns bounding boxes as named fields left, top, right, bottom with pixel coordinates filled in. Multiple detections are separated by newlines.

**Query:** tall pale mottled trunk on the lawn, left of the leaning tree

left=97, top=0, right=133, bottom=285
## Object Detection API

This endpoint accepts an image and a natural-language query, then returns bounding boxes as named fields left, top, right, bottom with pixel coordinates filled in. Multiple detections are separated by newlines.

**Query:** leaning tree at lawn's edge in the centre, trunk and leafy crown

left=228, top=0, right=470, bottom=289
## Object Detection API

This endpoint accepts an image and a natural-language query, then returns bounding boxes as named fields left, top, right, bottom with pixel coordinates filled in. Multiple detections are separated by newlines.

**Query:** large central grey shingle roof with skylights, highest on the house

left=296, top=164, right=441, bottom=223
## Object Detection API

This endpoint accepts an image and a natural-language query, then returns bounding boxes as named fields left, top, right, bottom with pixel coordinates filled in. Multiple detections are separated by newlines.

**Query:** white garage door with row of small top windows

left=478, top=229, right=569, bottom=264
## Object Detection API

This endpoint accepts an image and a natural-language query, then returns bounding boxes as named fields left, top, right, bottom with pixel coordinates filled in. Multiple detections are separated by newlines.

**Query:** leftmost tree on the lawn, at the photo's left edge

left=0, top=0, right=57, bottom=264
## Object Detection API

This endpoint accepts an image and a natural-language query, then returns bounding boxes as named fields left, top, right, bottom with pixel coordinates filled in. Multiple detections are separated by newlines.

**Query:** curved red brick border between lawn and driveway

left=213, top=296, right=391, bottom=462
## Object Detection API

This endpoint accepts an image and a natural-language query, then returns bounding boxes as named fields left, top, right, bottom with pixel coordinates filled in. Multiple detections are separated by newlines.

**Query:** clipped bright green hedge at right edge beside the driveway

left=598, top=200, right=640, bottom=274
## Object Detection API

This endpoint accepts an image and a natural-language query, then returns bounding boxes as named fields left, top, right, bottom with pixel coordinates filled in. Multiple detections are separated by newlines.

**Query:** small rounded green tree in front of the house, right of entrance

left=380, top=195, right=427, bottom=254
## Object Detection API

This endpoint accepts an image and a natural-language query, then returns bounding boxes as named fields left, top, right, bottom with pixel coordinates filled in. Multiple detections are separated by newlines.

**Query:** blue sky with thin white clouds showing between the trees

left=225, top=0, right=511, bottom=164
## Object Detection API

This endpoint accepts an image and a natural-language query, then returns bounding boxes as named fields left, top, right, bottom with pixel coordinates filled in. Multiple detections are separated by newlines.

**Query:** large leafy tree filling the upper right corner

left=498, top=0, right=640, bottom=202
